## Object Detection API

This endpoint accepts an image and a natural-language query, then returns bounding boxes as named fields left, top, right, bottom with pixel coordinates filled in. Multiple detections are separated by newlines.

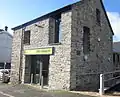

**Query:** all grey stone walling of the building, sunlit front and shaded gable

left=11, top=0, right=113, bottom=90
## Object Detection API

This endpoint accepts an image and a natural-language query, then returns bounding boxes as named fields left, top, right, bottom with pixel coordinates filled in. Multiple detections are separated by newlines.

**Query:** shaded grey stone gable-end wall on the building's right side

left=71, top=0, right=113, bottom=90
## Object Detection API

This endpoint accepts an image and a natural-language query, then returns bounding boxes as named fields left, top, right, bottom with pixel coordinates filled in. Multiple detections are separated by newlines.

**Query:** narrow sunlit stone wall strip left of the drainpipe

left=10, top=29, right=22, bottom=84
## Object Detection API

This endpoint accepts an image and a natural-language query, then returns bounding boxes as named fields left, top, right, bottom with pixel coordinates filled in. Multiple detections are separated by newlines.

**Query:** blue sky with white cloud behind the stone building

left=0, top=0, right=120, bottom=41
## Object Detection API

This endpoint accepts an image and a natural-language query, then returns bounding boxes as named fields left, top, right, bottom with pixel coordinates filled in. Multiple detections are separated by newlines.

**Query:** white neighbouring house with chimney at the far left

left=0, top=26, right=13, bottom=70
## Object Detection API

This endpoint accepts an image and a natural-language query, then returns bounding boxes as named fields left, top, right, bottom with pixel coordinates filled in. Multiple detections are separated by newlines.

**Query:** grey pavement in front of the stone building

left=0, top=83, right=94, bottom=97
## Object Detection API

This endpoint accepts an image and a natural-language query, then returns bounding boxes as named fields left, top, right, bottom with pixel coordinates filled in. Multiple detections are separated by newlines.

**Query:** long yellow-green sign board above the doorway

left=24, top=47, right=53, bottom=55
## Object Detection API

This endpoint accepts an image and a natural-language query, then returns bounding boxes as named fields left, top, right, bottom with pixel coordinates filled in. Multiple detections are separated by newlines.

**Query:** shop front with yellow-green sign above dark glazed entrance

left=24, top=48, right=53, bottom=86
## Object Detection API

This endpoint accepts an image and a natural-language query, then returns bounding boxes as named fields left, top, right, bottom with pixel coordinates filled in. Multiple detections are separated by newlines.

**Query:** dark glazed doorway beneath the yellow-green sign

left=26, top=55, right=49, bottom=86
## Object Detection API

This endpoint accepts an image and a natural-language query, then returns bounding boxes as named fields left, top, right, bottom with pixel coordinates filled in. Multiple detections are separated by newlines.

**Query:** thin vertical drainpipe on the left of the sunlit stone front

left=19, top=25, right=25, bottom=84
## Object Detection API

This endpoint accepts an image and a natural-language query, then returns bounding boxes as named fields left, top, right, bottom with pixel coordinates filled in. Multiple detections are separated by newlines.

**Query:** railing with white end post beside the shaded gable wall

left=99, top=70, right=120, bottom=95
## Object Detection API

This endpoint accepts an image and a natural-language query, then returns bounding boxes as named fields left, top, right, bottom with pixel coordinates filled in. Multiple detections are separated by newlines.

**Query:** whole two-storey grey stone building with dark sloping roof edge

left=11, top=0, right=113, bottom=90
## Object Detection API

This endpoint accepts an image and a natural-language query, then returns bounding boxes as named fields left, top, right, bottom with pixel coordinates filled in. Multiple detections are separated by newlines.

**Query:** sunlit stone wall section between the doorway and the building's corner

left=49, top=12, right=72, bottom=90
